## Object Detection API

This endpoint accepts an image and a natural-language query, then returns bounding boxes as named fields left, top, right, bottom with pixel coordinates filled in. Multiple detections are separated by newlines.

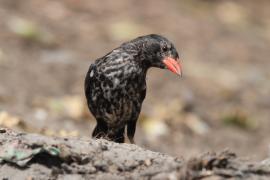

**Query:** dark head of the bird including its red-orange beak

left=139, top=34, right=182, bottom=76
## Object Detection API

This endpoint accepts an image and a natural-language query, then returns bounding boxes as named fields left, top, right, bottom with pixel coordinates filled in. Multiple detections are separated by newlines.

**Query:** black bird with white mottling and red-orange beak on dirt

left=84, top=34, right=182, bottom=143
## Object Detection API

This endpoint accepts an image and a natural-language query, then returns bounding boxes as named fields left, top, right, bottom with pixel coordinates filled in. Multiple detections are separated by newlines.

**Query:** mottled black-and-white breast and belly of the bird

left=88, top=59, right=146, bottom=126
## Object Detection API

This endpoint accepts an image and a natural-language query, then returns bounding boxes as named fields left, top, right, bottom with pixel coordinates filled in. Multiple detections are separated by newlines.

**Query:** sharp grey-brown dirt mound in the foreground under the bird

left=0, top=128, right=270, bottom=180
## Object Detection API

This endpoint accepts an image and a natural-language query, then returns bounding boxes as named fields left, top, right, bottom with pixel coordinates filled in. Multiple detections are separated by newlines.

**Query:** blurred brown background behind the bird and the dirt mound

left=0, top=0, right=270, bottom=159
